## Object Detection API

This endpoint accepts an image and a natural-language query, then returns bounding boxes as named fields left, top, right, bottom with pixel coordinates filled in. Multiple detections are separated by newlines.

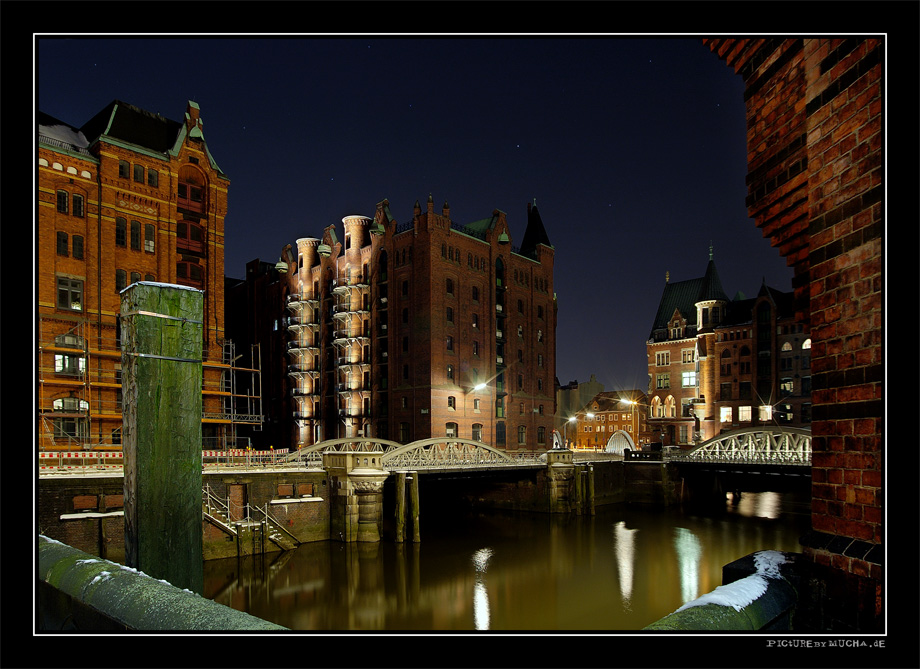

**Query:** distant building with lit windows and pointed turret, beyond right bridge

left=646, top=252, right=811, bottom=447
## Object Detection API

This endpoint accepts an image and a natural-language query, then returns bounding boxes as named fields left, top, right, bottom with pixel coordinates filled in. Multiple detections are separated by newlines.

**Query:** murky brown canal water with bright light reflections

left=204, top=493, right=810, bottom=632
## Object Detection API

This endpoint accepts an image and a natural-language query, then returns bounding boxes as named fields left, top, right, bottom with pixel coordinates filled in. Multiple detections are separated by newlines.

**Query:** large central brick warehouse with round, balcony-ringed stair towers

left=234, top=197, right=556, bottom=450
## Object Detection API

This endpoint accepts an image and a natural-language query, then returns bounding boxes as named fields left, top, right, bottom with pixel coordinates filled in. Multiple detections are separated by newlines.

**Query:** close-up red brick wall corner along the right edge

left=704, top=37, right=885, bottom=631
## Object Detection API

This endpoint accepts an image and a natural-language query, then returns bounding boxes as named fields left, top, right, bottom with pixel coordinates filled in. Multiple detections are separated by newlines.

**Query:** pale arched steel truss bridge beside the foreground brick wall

left=668, top=426, right=811, bottom=467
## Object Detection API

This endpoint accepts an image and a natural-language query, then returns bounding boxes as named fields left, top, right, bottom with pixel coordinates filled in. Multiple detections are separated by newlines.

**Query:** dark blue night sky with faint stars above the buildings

left=35, top=36, right=792, bottom=390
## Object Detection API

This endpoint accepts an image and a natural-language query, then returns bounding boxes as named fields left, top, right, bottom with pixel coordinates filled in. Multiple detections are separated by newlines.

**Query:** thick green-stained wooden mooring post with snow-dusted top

left=121, top=282, right=204, bottom=594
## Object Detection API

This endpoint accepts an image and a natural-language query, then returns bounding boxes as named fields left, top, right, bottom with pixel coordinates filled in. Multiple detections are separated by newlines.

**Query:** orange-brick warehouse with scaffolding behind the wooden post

left=36, top=101, right=258, bottom=450
